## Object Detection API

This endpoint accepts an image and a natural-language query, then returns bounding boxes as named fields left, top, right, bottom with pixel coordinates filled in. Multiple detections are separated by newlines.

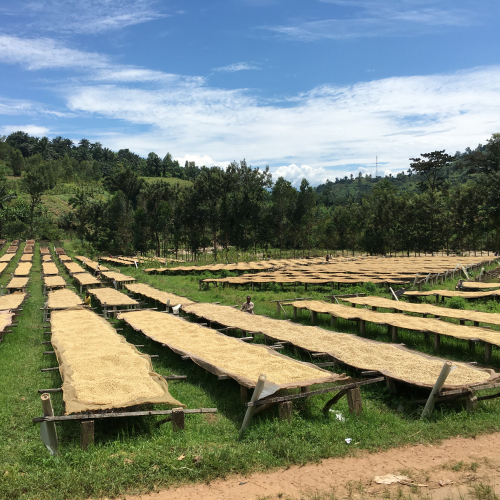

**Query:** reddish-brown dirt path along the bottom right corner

left=127, top=433, right=500, bottom=500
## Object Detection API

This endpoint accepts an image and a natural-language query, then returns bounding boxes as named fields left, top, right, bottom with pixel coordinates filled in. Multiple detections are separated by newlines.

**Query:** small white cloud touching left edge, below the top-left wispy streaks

left=0, top=35, right=109, bottom=70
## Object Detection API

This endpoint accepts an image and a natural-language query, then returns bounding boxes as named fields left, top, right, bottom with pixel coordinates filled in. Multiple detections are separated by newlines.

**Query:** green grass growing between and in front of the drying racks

left=0, top=243, right=500, bottom=500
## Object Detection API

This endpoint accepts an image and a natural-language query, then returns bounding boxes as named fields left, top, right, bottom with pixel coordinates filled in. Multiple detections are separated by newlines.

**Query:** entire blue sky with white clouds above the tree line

left=0, top=0, right=500, bottom=185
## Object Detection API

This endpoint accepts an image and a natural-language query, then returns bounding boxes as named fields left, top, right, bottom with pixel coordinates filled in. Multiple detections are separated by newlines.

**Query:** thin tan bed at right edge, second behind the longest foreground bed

left=348, top=297, right=500, bottom=325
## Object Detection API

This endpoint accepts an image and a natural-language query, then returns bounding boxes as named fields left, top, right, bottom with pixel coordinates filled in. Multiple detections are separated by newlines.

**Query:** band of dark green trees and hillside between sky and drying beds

left=0, top=131, right=500, bottom=259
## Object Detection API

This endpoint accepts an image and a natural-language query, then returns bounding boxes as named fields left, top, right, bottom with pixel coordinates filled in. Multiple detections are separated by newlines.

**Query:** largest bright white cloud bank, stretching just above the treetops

left=61, top=67, right=500, bottom=186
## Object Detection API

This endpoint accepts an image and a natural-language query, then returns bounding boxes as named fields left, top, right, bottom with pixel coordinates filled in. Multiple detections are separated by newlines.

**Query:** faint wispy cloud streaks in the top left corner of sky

left=4, top=0, right=167, bottom=34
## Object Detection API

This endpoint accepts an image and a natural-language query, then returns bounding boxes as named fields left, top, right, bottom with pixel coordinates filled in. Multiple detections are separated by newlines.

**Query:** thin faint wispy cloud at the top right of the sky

left=261, top=0, right=477, bottom=42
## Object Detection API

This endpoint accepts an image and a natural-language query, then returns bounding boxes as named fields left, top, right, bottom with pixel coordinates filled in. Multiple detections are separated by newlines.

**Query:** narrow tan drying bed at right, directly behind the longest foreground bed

left=292, top=300, right=500, bottom=346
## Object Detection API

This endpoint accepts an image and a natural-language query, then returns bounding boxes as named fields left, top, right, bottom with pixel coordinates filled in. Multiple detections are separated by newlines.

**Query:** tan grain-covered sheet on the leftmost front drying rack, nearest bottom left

left=51, top=308, right=185, bottom=415
